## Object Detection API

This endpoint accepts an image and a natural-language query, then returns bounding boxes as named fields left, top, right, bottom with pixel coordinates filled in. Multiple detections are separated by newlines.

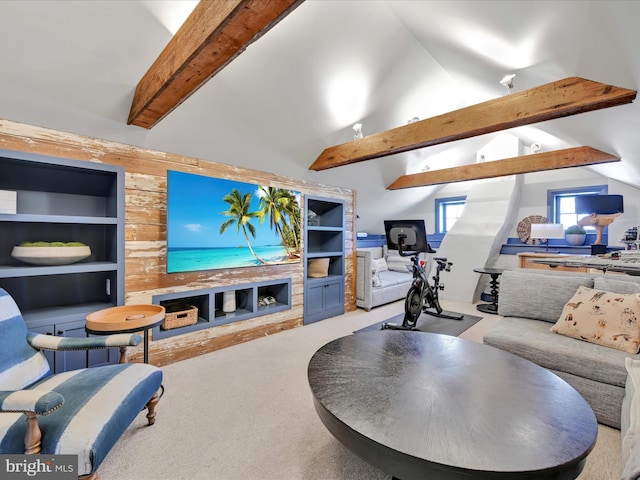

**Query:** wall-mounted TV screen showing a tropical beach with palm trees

left=167, top=170, right=300, bottom=273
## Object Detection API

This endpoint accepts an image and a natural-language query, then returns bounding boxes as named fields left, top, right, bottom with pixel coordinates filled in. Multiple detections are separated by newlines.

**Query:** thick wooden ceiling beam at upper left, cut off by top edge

left=127, top=0, right=304, bottom=128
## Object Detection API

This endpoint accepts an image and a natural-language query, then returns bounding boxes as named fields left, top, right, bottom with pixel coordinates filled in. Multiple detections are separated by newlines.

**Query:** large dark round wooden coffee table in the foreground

left=308, top=330, right=598, bottom=480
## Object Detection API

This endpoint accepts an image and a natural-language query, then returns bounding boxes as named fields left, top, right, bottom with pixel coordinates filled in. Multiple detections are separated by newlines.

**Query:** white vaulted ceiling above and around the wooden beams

left=0, top=0, right=640, bottom=230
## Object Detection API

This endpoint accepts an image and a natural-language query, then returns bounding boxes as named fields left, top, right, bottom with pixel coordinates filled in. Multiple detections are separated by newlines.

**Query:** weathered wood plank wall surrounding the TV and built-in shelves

left=0, top=119, right=356, bottom=365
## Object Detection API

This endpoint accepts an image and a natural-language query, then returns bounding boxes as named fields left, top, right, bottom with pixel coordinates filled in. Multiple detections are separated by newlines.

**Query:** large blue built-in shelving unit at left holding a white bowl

left=0, top=150, right=125, bottom=373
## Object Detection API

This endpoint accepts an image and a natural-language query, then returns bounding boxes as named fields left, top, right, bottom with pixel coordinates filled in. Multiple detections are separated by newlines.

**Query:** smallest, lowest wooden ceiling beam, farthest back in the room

left=387, top=147, right=620, bottom=190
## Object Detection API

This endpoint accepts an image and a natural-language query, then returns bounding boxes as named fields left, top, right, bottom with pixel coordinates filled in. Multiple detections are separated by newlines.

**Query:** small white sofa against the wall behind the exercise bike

left=356, top=246, right=431, bottom=311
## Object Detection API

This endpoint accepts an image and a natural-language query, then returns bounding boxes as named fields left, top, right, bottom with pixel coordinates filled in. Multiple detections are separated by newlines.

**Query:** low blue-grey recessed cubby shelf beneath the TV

left=152, top=278, right=291, bottom=340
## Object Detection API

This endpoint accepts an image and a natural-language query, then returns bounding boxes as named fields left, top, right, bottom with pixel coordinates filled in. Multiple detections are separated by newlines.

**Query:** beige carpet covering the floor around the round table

left=98, top=302, right=621, bottom=480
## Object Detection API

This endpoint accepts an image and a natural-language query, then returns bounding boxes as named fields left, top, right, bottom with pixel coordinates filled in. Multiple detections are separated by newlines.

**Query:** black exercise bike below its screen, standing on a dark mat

left=382, top=235, right=464, bottom=330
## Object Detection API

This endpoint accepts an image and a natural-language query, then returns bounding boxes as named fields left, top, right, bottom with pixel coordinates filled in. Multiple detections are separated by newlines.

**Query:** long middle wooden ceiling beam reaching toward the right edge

left=309, top=77, right=636, bottom=170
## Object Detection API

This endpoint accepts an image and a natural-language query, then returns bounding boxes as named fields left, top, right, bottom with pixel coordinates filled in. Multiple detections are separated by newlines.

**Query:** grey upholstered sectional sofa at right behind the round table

left=484, top=269, right=640, bottom=429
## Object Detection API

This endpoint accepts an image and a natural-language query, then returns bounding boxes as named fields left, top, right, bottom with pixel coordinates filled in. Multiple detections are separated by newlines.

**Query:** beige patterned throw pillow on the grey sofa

left=551, top=286, right=640, bottom=353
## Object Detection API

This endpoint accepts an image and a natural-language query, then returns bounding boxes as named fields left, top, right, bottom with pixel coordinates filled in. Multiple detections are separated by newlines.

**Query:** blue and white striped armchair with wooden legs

left=0, top=288, right=162, bottom=480
